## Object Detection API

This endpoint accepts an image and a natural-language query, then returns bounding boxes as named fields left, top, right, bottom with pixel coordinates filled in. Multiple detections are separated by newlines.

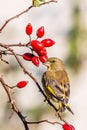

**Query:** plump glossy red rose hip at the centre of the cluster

left=30, top=40, right=44, bottom=50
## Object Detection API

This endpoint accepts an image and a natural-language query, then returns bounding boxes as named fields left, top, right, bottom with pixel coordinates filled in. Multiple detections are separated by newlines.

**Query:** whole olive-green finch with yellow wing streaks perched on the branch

left=42, top=57, right=73, bottom=114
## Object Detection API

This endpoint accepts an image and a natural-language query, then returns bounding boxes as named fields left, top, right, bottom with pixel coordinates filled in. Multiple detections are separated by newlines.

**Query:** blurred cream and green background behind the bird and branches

left=0, top=0, right=87, bottom=130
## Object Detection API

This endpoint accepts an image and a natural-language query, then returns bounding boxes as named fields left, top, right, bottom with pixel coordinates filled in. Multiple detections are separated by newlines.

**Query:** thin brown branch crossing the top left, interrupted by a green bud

left=0, top=0, right=57, bottom=32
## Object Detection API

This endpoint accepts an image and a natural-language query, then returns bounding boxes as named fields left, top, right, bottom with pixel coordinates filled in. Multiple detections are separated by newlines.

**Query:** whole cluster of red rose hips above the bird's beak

left=23, top=23, right=55, bottom=66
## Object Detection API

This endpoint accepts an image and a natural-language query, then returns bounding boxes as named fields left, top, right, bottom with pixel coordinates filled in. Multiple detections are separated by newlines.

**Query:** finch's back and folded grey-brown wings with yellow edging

left=44, top=71, right=70, bottom=101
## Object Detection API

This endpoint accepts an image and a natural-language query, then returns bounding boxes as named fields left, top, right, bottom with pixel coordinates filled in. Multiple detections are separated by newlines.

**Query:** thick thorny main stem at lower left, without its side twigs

left=0, top=77, right=29, bottom=130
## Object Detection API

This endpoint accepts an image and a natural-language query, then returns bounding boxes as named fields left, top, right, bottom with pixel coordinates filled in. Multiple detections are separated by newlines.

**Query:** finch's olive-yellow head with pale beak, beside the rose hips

left=44, top=57, right=65, bottom=70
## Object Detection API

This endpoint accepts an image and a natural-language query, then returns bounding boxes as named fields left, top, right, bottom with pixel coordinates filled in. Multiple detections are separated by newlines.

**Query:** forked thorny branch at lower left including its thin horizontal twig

left=0, top=77, right=62, bottom=130
